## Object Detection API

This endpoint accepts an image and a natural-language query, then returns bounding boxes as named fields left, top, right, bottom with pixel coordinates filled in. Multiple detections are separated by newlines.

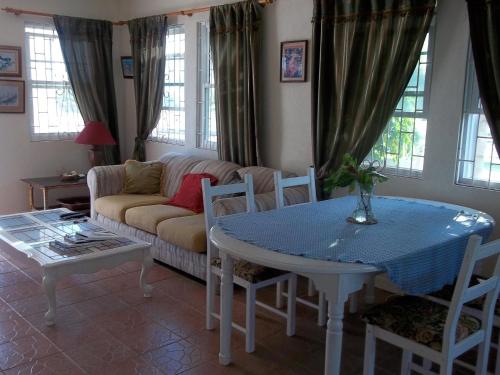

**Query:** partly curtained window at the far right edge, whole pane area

left=456, top=46, right=500, bottom=190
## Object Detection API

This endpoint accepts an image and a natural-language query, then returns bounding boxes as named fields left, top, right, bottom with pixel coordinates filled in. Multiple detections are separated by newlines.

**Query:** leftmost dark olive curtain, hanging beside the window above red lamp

left=54, top=16, right=120, bottom=164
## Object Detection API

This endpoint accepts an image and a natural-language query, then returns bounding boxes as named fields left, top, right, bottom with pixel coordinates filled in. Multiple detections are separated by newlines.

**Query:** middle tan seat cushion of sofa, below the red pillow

left=125, top=204, right=194, bottom=234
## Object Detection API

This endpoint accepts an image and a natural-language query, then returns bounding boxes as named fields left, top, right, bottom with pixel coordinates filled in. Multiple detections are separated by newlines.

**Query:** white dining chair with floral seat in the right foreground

left=364, top=235, right=500, bottom=375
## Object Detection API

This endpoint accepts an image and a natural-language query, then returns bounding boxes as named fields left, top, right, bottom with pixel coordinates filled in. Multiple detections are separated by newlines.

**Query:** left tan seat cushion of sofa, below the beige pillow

left=94, top=194, right=167, bottom=223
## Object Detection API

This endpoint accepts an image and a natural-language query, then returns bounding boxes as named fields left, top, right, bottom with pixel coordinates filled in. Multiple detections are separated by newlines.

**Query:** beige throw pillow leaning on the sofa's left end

left=123, top=160, right=163, bottom=194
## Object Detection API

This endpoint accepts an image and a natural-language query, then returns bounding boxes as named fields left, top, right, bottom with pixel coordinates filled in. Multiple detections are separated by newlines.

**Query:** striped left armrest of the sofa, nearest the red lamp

left=87, top=164, right=125, bottom=219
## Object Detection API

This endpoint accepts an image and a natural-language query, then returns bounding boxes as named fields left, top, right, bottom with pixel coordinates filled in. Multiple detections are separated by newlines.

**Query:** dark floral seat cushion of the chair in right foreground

left=363, top=296, right=481, bottom=351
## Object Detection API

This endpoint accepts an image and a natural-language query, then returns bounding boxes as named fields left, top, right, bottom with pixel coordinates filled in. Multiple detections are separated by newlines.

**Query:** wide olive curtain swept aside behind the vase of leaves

left=311, top=0, right=435, bottom=184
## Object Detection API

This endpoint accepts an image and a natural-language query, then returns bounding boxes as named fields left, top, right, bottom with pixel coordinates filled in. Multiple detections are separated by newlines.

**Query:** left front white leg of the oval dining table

left=219, top=251, right=234, bottom=366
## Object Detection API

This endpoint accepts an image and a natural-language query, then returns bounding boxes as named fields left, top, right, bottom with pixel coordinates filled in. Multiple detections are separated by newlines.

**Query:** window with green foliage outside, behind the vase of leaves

left=367, top=28, right=432, bottom=177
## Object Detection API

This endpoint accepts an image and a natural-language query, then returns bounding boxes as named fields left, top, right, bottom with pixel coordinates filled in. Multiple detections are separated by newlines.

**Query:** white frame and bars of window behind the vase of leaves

left=365, top=24, right=436, bottom=179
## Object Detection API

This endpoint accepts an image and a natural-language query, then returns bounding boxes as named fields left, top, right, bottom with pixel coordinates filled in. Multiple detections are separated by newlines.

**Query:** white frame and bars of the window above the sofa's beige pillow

left=148, top=23, right=187, bottom=146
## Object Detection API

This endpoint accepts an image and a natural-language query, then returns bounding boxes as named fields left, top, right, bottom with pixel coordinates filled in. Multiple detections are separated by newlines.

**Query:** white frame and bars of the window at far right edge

left=454, top=41, right=500, bottom=191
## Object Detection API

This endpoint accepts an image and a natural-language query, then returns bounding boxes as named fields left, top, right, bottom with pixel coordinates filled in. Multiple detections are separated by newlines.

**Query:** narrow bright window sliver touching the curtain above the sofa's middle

left=197, top=22, right=217, bottom=150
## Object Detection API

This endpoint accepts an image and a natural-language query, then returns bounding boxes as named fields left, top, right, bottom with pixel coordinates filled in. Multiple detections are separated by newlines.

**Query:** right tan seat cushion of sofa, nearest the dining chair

left=156, top=214, right=207, bottom=253
